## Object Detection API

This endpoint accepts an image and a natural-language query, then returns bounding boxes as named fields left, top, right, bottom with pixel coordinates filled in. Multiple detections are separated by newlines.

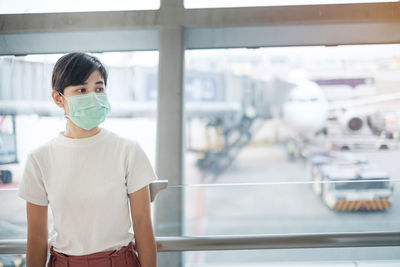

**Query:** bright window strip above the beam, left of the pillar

left=0, top=0, right=160, bottom=14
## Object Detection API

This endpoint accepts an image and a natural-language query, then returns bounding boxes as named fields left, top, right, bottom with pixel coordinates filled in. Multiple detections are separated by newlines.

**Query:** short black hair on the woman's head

left=51, top=52, right=108, bottom=94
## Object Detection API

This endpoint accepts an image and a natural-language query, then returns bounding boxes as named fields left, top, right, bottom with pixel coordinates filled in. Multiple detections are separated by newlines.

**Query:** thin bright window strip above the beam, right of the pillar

left=184, top=0, right=397, bottom=8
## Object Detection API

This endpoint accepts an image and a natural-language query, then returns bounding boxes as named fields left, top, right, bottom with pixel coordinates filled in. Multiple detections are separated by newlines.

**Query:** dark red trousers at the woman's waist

left=47, top=242, right=140, bottom=267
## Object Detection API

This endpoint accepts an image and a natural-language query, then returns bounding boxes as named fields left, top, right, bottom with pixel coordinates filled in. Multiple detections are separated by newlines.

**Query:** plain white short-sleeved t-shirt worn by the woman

left=18, top=128, right=157, bottom=255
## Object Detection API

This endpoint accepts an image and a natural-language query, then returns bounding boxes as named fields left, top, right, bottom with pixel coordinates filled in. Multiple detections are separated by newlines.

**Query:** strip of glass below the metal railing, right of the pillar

left=183, top=251, right=400, bottom=267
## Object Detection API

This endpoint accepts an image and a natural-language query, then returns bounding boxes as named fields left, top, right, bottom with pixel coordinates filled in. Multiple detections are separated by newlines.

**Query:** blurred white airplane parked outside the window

left=282, top=76, right=400, bottom=161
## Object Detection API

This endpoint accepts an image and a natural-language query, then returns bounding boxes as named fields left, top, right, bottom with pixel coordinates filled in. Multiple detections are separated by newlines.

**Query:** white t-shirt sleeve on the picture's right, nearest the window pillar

left=126, top=142, right=157, bottom=194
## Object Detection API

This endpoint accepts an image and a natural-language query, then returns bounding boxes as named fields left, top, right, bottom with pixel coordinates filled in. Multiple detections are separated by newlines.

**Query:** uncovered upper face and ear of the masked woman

left=57, top=70, right=106, bottom=114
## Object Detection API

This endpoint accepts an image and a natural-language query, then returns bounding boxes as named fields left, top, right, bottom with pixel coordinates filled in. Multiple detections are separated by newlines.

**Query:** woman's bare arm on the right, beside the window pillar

left=129, top=186, right=157, bottom=267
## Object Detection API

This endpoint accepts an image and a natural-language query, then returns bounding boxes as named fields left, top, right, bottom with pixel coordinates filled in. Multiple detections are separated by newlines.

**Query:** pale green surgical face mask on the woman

left=60, top=92, right=111, bottom=130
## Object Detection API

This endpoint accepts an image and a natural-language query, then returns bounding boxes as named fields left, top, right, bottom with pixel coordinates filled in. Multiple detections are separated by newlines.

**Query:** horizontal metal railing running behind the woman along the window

left=0, top=232, right=400, bottom=254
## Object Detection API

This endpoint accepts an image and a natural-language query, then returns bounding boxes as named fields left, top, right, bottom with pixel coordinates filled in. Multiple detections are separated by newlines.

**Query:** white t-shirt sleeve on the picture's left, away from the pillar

left=18, top=154, right=49, bottom=206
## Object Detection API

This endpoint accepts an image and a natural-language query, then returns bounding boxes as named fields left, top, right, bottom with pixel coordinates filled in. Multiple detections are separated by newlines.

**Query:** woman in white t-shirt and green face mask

left=18, top=53, right=157, bottom=267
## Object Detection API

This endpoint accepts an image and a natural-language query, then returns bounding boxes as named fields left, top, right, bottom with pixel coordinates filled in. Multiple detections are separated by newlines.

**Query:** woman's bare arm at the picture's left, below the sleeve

left=26, top=202, right=48, bottom=267
